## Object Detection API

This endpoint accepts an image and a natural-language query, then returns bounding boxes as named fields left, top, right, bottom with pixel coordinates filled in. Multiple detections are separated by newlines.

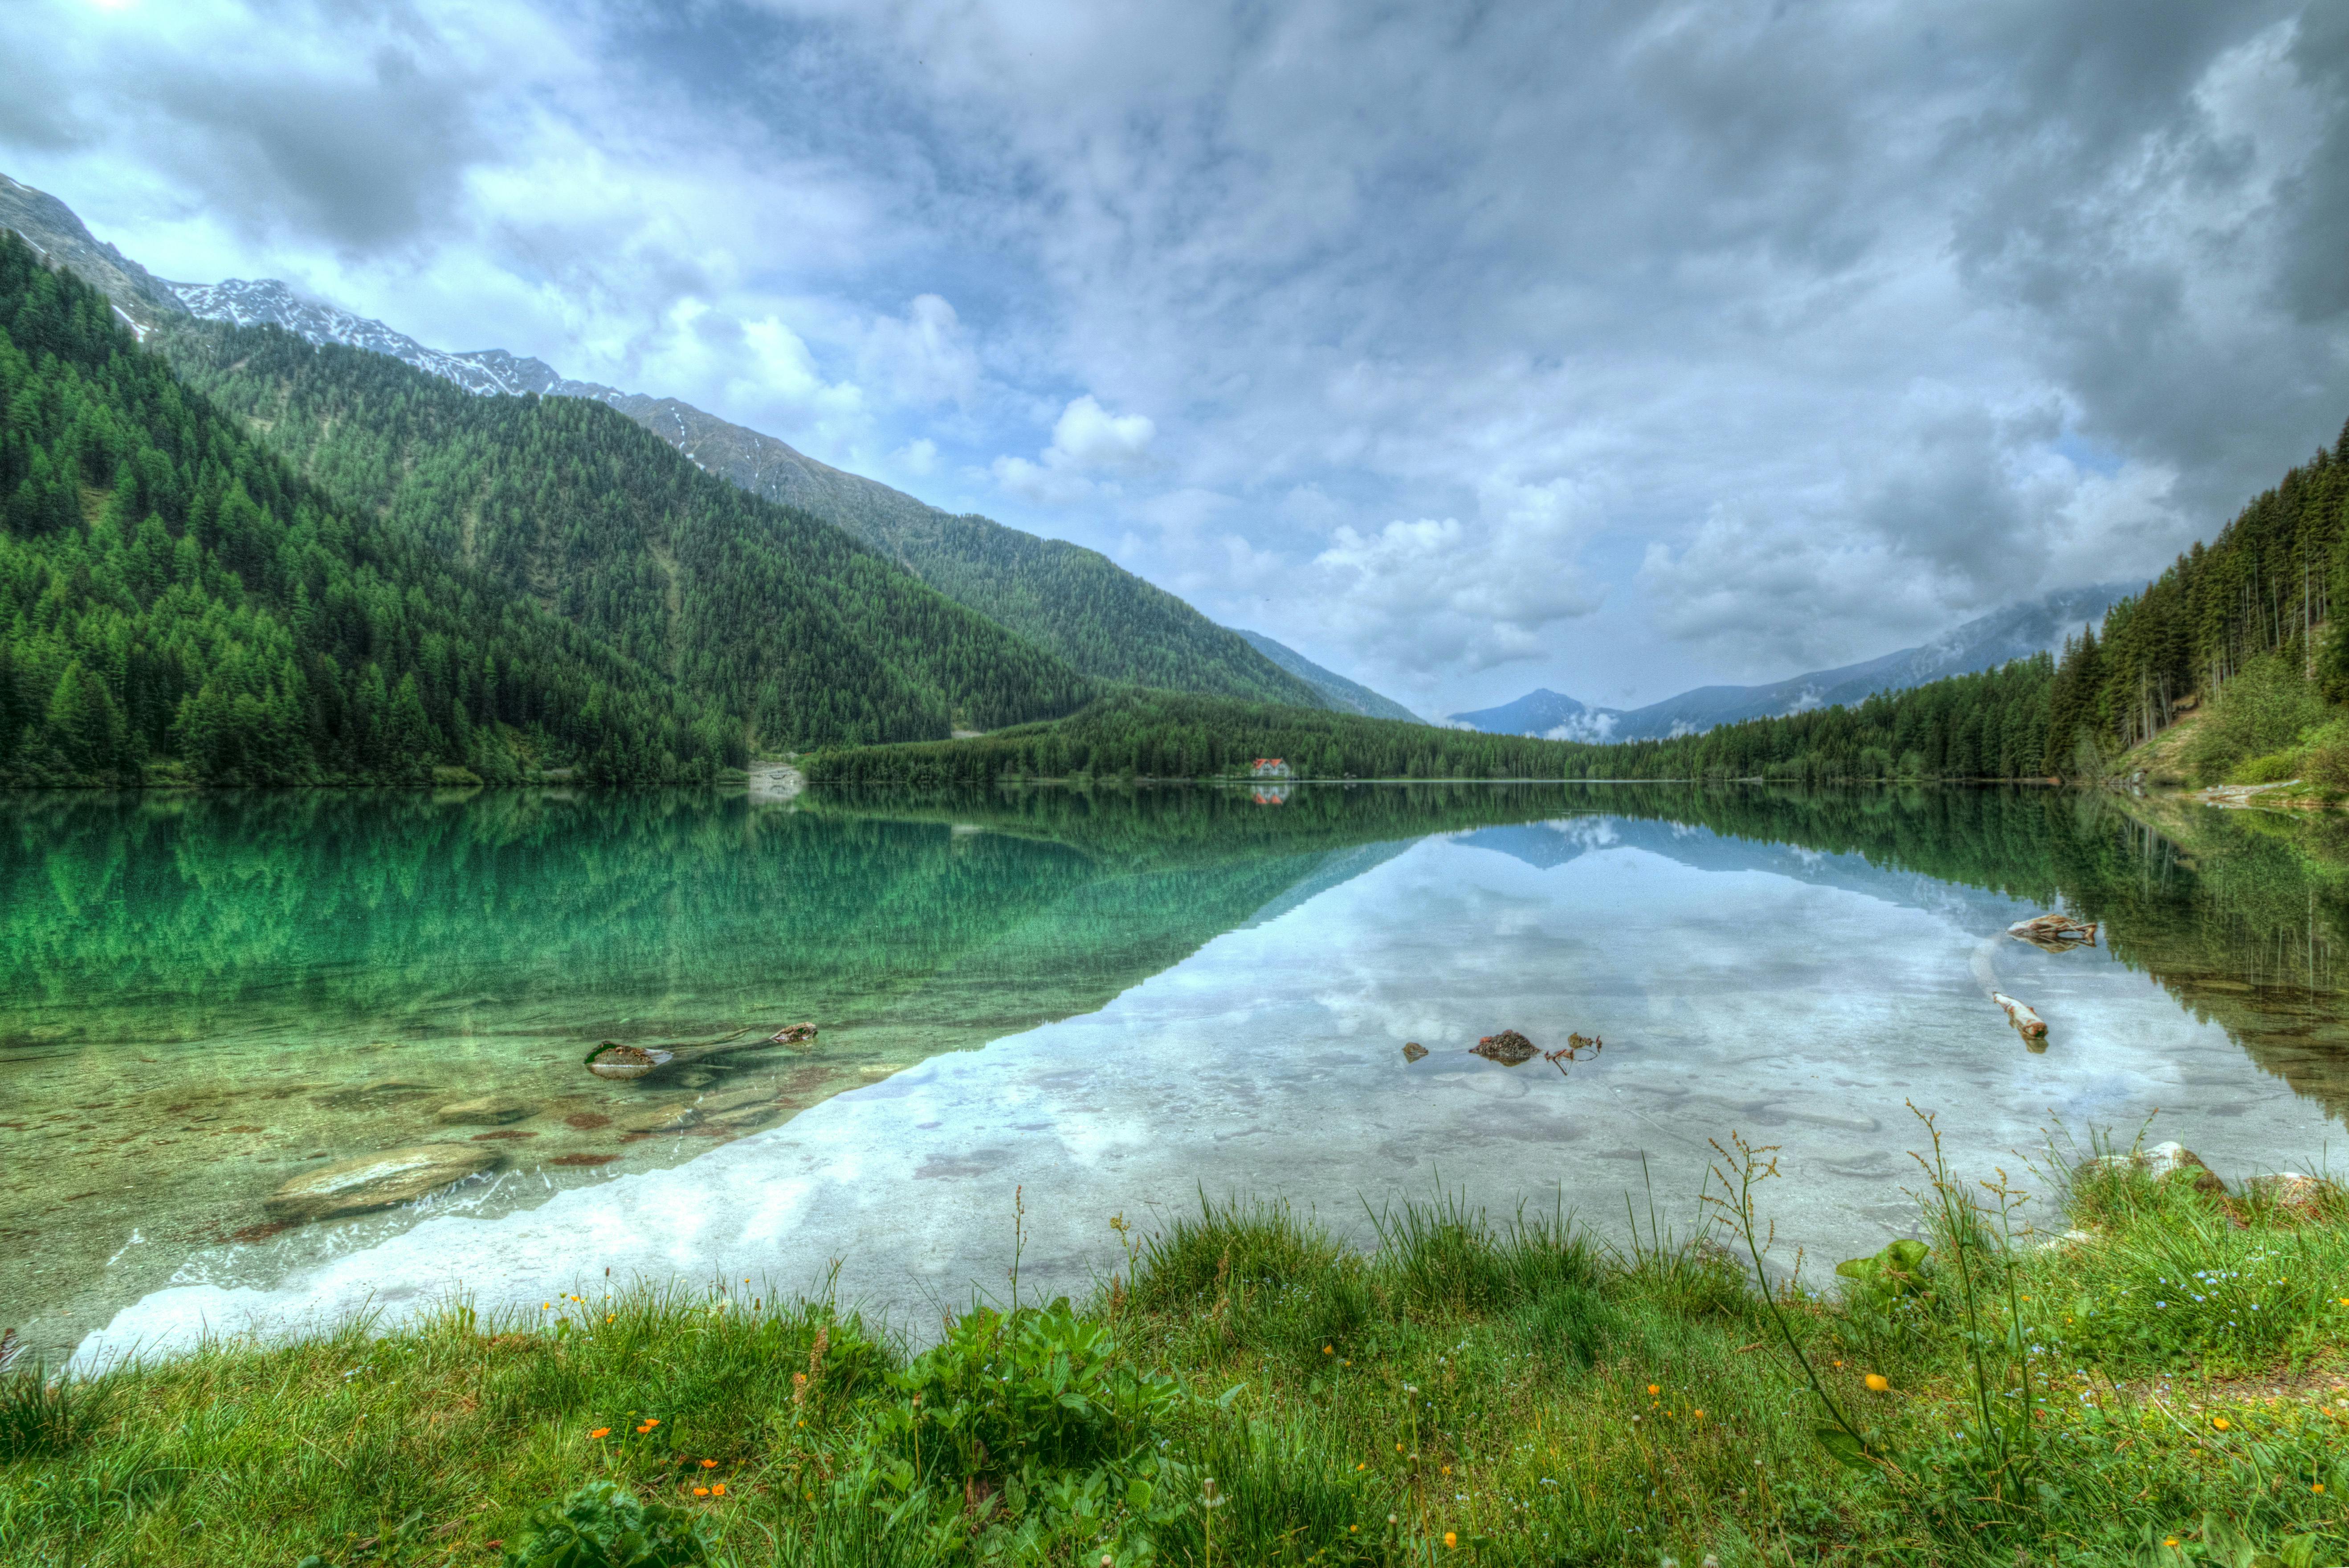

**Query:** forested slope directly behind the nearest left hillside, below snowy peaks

left=153, top=322, right=1090, bottom=746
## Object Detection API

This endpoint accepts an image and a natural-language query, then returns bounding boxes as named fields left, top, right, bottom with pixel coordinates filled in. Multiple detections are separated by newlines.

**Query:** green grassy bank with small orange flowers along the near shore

left=0, top=1169, right=2349, bottom=1568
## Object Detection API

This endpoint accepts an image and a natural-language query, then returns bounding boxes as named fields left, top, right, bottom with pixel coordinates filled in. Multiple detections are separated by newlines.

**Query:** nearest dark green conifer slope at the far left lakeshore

left=0, top=232, right=728, bottom=784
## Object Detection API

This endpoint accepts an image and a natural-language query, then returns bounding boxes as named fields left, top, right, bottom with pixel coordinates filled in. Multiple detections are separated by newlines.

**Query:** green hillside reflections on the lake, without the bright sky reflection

left=13, top=786, right=2349, bottom=1345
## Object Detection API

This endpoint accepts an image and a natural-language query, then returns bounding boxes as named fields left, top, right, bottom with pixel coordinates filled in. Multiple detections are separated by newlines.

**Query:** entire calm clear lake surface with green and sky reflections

left=13, top=786, right=2349, bottom=1361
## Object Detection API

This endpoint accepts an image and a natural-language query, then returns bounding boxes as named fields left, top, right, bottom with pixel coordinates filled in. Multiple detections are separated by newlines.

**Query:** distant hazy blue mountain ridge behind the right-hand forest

left=1449, top=582, right=2131, bottom=742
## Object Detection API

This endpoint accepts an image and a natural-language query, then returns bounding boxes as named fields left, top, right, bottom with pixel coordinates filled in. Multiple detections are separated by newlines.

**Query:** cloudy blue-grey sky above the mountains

left=0, top=0, right=2349, bottom=716
